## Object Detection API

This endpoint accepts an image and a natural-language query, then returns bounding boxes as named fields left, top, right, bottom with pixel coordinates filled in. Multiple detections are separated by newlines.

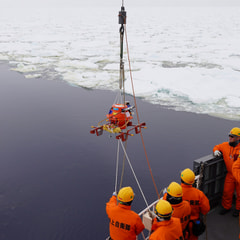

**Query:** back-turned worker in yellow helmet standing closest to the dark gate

left=181, top=168, right=210, bottom=240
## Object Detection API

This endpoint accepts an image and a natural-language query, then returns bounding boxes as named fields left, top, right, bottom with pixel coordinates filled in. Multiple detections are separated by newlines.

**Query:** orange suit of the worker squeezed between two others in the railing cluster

left=163, top=193, right=191, bottom=231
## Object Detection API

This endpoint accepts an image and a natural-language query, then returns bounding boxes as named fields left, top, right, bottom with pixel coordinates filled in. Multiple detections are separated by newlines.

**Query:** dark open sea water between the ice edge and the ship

left=0, top=65, right=239, bottom=240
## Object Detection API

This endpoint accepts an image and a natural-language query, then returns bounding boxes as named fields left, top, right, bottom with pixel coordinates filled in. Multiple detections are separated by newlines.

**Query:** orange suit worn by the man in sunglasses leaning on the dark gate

left=213, top=142, right=240, bottom=210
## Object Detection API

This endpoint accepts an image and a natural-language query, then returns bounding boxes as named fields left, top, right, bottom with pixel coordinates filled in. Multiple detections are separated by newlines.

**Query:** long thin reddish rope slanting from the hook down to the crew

left=124, top=24, right=160, bottom=199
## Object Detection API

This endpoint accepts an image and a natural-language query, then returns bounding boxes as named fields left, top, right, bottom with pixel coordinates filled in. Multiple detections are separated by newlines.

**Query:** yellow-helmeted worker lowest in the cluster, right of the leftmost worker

left=149, top=199, right=184, bottom=240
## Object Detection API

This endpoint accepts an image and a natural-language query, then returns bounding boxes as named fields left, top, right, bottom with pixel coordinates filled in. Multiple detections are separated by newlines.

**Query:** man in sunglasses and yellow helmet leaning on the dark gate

left=213, top=127, right=240, bottom=217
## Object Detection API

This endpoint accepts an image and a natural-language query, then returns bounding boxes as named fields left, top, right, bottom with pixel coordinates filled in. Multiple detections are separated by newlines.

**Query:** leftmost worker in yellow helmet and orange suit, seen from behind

left=106, top=187, right=145, bottom=240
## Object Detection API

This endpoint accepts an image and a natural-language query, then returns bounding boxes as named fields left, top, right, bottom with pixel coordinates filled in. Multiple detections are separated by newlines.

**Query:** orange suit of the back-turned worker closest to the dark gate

left=181, top=183, right=210, bottom=240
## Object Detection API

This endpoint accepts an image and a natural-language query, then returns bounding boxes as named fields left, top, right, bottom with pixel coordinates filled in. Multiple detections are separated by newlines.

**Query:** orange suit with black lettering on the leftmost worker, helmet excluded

left=106, top=196, right=145, bottom=240
